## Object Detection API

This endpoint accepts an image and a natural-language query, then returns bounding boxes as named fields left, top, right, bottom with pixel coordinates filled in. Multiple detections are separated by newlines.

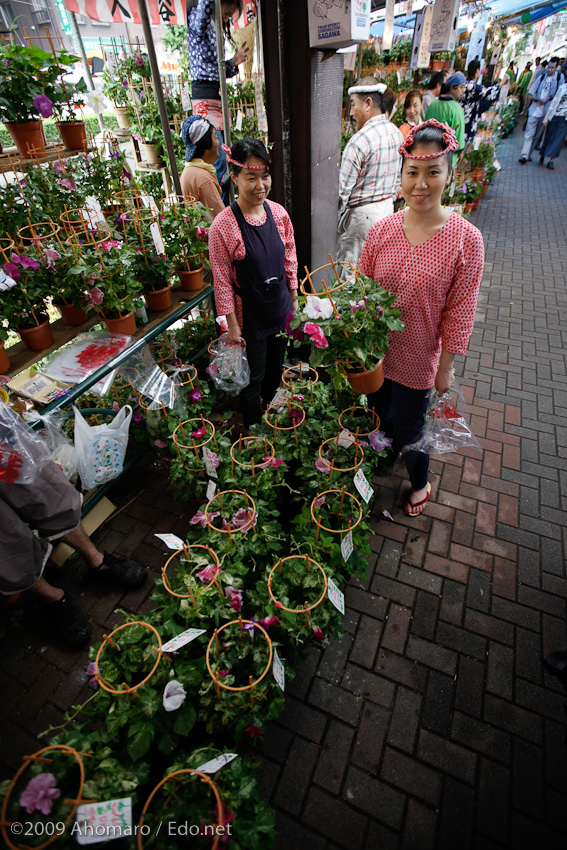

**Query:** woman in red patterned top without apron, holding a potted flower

left=359, top=119, right=484, bottom=516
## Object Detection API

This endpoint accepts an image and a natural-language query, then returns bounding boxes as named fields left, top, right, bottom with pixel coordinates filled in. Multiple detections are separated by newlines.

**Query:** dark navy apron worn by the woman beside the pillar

left=231, top=201, right=291, bottom=342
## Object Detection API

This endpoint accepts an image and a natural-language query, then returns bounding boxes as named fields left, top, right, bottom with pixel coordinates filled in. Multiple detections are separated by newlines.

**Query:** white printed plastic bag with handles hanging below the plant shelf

left=74, top=404, right=132, bottom=490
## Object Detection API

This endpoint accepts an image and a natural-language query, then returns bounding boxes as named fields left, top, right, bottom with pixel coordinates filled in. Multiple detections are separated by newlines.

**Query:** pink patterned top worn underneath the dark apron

left=209, top=201, right=297, bottom=327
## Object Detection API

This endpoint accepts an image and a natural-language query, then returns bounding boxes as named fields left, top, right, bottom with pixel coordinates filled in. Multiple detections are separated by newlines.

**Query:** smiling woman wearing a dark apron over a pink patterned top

left=209, top=139, right=298, bottom=429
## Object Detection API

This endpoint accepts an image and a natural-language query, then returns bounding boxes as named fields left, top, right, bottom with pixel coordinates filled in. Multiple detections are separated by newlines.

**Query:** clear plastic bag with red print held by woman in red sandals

left=401, top=383, right=482, bottom=455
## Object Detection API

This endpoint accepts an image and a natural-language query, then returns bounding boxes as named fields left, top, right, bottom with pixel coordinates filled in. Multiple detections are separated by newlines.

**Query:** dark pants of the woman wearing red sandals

left=368, top=378, right=429, bottom=490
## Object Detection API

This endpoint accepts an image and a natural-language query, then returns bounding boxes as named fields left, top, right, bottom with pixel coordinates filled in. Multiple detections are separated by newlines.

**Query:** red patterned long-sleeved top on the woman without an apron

left=358, top=210, right=484, bottom=390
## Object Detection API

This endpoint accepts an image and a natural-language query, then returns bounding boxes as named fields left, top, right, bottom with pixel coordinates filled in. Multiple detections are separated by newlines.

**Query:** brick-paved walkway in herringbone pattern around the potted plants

left=0, top=130, right=567, bottom=850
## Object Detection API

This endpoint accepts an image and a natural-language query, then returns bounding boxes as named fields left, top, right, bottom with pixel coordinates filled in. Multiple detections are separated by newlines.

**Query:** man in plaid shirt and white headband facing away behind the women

left=337, top=77, right=403, bottom=264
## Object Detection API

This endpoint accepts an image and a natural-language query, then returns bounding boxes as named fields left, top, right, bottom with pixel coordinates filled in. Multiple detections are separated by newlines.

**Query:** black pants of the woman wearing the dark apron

left=240, top=334, right=287, bottom=428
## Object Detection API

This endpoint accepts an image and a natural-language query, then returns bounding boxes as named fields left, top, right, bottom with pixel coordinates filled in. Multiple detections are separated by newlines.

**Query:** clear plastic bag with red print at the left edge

left=0, top=402, right=50, bottom=484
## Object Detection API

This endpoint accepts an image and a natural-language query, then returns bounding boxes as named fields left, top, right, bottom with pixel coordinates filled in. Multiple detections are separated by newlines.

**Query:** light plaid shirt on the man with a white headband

left=339, top=115, right=404, bottom=212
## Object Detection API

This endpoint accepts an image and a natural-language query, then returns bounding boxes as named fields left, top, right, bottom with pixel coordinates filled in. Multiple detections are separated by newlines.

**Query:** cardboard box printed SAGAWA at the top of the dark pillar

left=307, top=0, right=371, bottom=50
